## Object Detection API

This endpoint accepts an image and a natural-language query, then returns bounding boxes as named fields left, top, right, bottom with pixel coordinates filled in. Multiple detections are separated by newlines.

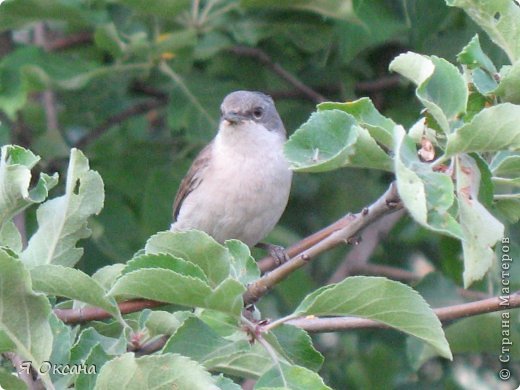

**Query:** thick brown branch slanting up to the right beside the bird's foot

left=244, top=182, right=403, bottom=304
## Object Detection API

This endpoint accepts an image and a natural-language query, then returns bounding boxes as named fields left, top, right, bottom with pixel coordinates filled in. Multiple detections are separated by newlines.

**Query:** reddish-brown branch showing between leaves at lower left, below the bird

left=54, top=299, right=165, bottom=324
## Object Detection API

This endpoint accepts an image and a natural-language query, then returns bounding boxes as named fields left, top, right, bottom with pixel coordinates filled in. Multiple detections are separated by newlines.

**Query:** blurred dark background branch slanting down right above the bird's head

left=229, top=46, right=326, bottom=103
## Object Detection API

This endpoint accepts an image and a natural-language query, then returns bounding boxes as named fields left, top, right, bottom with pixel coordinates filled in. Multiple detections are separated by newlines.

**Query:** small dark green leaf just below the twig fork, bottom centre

left=271, top=324, right=324, bottom=372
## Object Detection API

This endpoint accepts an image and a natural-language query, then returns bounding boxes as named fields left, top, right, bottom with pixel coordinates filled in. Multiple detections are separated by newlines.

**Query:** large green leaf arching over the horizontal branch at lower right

left=294, top=276, right=452, bottom=359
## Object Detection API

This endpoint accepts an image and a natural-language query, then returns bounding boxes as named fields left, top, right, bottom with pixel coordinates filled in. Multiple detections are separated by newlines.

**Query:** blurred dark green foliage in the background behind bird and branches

left=0, top=0, right=520, bottom=388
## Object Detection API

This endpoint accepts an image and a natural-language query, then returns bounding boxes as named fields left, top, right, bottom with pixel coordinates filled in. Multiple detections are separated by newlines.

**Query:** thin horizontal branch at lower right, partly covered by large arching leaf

left=286, top=292, right=520, bottom=332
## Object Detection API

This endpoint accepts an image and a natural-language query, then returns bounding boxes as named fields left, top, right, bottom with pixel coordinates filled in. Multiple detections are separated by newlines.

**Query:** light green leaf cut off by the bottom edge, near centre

left=255, top=363, right=331, bottom=390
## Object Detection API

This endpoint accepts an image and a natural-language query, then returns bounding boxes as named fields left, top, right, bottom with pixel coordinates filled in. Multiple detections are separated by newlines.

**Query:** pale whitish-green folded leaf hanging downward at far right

left=456, top=155, right=504, bottom=287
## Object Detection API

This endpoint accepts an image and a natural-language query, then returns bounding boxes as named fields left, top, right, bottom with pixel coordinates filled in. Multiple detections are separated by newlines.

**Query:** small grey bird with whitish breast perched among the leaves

left=171, top=91, right=292, bottom=257
